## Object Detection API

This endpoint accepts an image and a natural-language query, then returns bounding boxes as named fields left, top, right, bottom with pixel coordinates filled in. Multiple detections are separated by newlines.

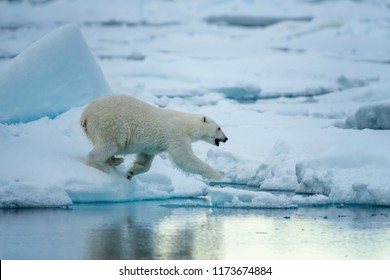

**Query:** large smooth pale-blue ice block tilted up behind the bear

left=0, top=24, right=111, bottom=124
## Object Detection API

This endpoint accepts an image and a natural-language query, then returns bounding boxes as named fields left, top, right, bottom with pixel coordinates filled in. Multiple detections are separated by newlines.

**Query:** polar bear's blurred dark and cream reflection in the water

left=87, top=202, right=223, bottom=259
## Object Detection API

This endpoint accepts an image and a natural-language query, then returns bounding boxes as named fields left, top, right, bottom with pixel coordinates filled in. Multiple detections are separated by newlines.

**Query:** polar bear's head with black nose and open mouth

left=199, top=116, right=228, bottom=146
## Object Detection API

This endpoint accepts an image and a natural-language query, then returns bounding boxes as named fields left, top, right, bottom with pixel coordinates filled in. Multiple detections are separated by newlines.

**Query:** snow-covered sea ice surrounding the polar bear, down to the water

left=0, top=0, right=390, bottom=208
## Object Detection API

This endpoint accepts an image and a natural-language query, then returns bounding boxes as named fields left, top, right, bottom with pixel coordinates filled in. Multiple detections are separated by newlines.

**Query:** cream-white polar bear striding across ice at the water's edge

left=80, top=95, right=228, bottom=180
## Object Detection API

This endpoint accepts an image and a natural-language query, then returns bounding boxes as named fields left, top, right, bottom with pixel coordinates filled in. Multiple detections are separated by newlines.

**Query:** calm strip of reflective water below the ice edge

left=0, top=200, right=390, bottom=260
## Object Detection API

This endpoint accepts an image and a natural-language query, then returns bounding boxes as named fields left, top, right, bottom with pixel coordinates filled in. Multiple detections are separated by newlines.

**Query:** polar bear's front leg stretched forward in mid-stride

left=168, top=143, right=225, bottom=181
